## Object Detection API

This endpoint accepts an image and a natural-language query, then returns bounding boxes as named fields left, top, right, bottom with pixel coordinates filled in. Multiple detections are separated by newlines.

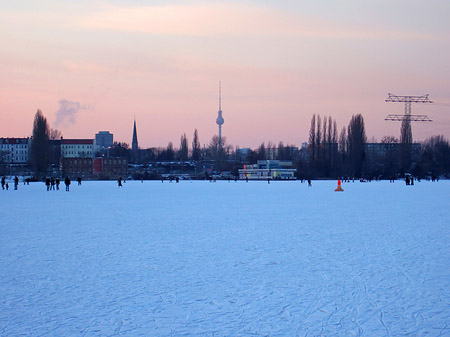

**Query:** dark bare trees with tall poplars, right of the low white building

left=304, top=114, right=450, bottom=179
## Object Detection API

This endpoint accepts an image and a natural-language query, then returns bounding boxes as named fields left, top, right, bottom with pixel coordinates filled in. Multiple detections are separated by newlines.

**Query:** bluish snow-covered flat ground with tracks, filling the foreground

left=0, top=181, right=450, bottom=336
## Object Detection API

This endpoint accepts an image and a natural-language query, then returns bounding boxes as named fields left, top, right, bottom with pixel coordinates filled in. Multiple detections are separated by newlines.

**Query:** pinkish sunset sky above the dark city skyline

left=0, top=0, right=450, bottom=148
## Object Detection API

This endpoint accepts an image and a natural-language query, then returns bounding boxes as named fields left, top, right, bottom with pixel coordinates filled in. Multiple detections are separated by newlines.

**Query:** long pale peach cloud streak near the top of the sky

left=81, top=3, right=433, bottom=39
